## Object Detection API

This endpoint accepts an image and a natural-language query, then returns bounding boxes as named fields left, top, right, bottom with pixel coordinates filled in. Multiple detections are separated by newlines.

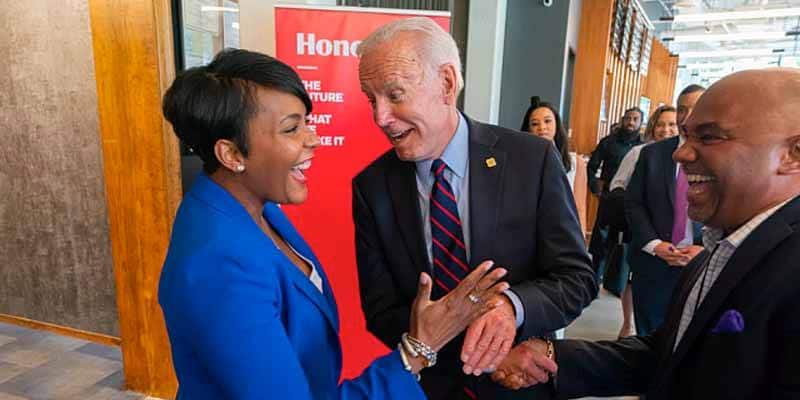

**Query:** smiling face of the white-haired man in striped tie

left=358, top=33, right=458, bottom=161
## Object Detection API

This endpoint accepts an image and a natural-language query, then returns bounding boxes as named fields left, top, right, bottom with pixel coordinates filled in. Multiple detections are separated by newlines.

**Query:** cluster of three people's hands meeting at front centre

left=409, top=261, right=556, bottom=389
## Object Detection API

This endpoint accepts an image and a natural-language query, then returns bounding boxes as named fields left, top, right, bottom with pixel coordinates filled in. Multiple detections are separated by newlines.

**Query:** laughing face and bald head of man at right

left=673, top=71, right=800, bottom=230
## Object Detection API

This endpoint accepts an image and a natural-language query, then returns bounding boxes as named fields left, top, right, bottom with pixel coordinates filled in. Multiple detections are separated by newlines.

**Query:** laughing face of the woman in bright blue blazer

left=240, top=87, right=319, bottom=204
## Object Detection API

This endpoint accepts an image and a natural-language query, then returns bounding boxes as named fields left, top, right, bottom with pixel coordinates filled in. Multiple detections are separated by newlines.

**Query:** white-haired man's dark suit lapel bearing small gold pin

left=467, top=119, right=506, bottom=266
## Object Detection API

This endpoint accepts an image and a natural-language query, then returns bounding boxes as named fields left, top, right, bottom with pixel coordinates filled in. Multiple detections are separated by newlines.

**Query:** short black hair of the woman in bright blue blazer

left=162, top=49, right=311, bottom=174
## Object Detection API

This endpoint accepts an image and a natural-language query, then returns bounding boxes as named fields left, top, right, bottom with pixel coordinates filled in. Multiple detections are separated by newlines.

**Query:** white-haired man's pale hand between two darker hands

left=461, top=294, right=517, bottom=376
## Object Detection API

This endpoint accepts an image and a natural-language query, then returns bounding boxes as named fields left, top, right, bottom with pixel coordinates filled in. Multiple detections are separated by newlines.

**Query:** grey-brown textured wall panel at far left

left=0, top=0, right=119, bottom=342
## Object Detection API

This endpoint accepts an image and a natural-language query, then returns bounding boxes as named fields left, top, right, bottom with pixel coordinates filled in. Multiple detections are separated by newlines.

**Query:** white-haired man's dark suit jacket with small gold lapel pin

left=353, top=114, right=597, bottom=398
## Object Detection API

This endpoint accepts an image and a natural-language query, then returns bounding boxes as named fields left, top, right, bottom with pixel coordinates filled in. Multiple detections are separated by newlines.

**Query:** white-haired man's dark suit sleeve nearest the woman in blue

left=353, top=180, right=411, bottom=348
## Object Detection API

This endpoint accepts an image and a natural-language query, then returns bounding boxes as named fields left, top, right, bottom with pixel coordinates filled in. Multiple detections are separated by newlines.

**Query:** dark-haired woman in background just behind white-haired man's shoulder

left=520, top=96, right=587, bottom=232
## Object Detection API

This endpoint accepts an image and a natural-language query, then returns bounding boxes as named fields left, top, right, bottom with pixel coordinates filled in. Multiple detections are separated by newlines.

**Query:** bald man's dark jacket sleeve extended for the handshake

left=553, top=330, right=664, bottom=399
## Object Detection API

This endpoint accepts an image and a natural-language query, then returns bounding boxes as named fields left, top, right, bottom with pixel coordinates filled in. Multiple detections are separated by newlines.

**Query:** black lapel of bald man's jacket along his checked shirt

left=664, top=200, right=800, bottom=384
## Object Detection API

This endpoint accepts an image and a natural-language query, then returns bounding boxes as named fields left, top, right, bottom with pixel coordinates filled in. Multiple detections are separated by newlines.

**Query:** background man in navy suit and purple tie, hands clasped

left=625, top=85, right=703, bottom=336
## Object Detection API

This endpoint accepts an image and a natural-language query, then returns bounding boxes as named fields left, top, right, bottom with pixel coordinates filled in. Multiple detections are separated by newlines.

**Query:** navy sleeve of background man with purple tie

left=625, top=148, right=660, bottom=251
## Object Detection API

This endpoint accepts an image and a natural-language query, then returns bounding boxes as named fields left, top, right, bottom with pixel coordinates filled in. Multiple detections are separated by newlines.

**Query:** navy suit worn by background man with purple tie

left=625, top=136, right=702, bottom=333
